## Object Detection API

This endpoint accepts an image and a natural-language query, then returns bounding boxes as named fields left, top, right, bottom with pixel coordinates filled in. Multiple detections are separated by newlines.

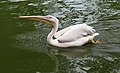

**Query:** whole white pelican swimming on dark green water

left=19, top=15, right=99, bottom=47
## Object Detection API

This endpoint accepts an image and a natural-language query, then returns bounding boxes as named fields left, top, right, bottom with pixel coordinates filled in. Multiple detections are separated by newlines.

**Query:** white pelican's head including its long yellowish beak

left=19, top=15, right=59, bottom=26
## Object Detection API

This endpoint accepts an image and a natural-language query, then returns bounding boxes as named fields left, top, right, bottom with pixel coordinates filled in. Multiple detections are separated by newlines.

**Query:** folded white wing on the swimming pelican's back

left=56, top=23, right=95, bottom=42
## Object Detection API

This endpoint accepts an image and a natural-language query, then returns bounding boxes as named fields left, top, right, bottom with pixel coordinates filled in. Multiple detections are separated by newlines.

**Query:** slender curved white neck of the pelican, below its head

left=47, top=23, right=58, bottom=45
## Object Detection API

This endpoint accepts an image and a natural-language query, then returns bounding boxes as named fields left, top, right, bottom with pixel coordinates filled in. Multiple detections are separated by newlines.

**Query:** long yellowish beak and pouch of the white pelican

left=19, top=16, right=52, bottom=23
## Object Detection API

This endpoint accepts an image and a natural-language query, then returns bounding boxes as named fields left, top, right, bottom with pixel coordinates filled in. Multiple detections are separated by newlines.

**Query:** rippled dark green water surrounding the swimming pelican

left=0, top=0, right=120, bottom=73
